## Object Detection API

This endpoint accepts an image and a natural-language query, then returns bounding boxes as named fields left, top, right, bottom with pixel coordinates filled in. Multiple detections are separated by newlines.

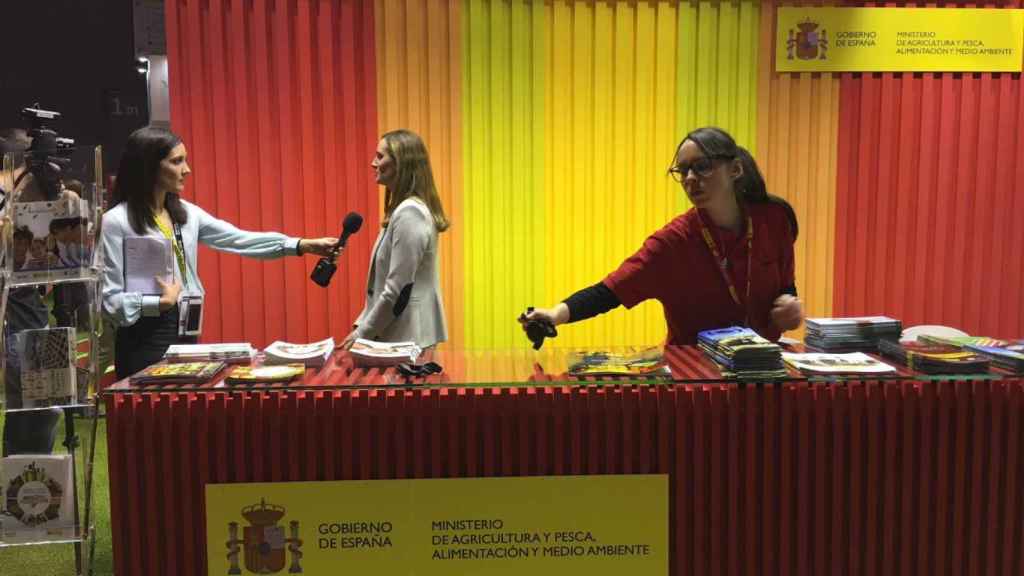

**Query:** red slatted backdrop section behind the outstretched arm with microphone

left=166, top=0, right=379, bottom=346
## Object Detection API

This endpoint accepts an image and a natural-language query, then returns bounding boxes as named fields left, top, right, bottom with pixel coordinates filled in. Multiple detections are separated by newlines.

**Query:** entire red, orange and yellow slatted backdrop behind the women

left=167, top=0, right=1024, bottom=347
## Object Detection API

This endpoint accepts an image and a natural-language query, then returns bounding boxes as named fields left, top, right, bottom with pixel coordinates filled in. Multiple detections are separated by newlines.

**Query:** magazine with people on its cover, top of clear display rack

left=11, top=198, right=93, bottom=283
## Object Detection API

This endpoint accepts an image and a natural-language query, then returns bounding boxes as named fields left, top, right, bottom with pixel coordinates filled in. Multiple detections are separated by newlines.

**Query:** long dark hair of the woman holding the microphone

left=112, top=126, right=188, bottom=235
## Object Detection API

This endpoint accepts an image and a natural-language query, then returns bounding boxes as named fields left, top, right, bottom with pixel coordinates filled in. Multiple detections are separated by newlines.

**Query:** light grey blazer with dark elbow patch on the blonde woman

left=355, top=198, right=447, bottom=347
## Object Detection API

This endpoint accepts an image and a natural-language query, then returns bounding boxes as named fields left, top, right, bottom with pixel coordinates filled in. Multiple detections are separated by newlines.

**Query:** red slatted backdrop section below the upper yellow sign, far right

left=834, top=1, right=1024, bottom=336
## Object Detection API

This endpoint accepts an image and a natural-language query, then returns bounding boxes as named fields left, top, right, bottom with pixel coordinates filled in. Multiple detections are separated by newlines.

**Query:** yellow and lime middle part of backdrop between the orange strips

left=460, top=0, right=760, bottom=347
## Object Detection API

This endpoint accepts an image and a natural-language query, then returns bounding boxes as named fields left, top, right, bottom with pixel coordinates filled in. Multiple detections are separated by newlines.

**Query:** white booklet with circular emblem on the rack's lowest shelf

left=0, top=454, right=75, bottom=542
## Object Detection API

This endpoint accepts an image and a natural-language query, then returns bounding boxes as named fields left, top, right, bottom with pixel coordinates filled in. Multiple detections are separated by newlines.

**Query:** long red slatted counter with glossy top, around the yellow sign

left=105, top=348, right=1024, bottom=576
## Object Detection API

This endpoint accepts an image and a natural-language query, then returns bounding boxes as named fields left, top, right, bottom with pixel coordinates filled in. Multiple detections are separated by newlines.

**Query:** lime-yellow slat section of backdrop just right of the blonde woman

left=462, top=0, right=548, bottom=347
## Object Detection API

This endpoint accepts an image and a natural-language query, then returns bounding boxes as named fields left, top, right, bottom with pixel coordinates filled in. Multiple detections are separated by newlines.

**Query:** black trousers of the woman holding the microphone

left=114, top=306, right=197, bottom=380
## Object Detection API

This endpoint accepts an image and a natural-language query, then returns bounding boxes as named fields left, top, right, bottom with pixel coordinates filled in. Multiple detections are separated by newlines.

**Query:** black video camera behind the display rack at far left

left=14, top=102, right=75, bottom=200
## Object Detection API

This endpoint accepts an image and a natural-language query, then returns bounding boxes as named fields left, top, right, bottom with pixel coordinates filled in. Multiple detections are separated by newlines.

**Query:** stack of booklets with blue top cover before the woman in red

left=697, top=326, right=788, bottom=378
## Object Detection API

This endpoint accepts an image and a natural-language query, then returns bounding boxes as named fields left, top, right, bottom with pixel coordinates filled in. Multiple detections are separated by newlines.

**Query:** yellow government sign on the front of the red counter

left=206, top=475, right=669, bottom=576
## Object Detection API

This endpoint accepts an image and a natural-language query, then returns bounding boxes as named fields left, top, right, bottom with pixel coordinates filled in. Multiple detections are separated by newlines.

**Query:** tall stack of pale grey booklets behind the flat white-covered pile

left=804, top=316, right=903, bottom=353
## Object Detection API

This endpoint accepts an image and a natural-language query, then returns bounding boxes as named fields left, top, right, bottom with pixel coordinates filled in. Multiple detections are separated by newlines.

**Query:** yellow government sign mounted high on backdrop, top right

left=775, top=7, right=1024, bottom=72
